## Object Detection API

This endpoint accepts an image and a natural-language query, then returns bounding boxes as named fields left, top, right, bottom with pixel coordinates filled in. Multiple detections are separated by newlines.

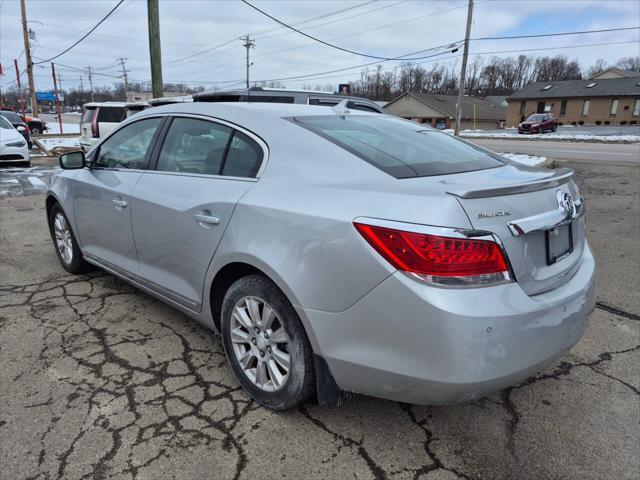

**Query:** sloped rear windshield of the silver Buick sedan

left=293, top=115, right=504, bottom=178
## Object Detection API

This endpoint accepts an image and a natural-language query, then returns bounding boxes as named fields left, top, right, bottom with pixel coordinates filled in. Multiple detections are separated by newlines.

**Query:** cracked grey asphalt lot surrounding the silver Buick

left=0, top=159, right=640, bottom=480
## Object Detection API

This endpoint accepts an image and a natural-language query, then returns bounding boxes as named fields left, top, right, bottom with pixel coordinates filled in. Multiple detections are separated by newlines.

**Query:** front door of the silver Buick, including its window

left=73, top=117, right=163, bottom=273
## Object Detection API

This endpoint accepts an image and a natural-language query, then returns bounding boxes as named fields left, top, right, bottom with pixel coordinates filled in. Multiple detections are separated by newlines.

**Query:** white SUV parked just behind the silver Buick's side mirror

left=79, top=102, right=127, bottom=152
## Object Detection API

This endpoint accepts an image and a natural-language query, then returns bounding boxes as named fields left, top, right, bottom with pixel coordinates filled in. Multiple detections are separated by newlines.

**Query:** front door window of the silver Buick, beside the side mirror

left=96, top=118, right=162, bottom=169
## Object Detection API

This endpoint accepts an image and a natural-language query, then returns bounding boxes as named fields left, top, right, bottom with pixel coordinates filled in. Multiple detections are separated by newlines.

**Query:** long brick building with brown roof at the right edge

left=507, top=68, right=640, bottom=127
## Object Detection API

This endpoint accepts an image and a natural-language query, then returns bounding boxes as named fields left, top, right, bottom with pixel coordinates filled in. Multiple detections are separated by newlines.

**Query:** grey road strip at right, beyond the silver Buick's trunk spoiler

left=472, top=138, right=640, bottom=166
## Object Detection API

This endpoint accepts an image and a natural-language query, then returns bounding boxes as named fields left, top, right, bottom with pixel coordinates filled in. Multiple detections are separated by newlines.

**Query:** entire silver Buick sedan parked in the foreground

left=46, top=102, right=595, bottom=409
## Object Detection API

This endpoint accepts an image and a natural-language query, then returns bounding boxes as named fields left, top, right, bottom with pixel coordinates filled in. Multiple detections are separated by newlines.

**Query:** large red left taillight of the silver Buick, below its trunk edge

left=354, top=223, right=511, bottom=286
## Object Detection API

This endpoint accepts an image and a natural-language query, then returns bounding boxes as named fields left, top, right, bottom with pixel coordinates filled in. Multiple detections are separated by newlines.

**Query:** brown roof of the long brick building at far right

left=509, top=77, right=640, bottom=99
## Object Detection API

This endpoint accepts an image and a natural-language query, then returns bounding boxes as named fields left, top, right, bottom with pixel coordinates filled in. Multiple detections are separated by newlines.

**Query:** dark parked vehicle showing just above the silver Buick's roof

left=193, top=87, right=385, bottom=113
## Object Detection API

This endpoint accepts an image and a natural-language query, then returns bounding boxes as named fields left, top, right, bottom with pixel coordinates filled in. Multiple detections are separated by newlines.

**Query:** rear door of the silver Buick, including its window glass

left=132, top=117, right=266, bottom=311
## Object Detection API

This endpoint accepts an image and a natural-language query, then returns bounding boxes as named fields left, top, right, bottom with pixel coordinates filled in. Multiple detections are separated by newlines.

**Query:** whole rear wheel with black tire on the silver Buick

left=221, top=275, right=315, bottom=410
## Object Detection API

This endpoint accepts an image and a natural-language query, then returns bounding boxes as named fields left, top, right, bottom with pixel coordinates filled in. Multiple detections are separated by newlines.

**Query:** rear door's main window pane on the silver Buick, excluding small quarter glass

left=156, top=118, right=233, bottom=175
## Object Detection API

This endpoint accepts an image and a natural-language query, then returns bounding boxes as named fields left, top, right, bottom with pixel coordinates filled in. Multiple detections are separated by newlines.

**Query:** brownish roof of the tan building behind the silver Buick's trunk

left=385, top=92, right=507, bottom=121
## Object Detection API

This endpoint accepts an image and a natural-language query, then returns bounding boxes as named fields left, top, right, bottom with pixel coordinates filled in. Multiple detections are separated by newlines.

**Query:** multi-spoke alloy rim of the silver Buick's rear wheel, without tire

left=230, top=296, right=291, bottom=392
